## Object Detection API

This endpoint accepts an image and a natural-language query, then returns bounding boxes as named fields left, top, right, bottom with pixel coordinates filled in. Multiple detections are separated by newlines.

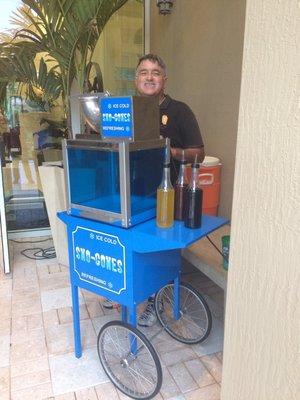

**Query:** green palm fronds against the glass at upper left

left=0, top=0, right=128, bottom=134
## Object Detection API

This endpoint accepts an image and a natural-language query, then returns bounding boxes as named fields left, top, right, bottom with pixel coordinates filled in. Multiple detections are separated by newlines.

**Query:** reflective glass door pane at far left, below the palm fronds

left=1, top=95, right=50, bottom=236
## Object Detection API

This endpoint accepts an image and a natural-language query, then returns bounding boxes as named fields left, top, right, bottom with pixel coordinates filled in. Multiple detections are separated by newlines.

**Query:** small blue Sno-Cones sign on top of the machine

left=99, top=96, right=133, bottom=139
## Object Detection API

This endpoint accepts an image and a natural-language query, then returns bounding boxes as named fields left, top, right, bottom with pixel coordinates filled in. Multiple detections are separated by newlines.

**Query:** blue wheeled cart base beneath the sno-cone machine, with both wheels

left=58, top=212, right=228, bottom=399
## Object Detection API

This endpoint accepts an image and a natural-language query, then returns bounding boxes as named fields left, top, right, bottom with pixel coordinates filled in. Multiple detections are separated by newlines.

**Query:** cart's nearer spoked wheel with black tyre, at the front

left=97, top=321, right=162, bottom=399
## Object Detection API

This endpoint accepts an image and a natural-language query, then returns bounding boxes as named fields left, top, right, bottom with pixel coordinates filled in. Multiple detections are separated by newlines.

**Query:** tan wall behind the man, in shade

left=150, top=0, right=246, bottom=218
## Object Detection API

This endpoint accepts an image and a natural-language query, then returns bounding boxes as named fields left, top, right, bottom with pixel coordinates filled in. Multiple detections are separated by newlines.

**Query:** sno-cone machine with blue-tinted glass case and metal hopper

left=64, top=93, right=165, bottom=228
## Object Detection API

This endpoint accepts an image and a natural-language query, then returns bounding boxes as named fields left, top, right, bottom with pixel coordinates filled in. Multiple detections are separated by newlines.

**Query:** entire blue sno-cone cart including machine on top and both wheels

left=58, top=95, right=227, bottom=399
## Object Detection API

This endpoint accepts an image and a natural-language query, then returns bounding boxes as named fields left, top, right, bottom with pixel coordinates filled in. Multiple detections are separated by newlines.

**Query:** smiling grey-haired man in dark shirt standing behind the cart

left=103, top=54, right=204, bottom=326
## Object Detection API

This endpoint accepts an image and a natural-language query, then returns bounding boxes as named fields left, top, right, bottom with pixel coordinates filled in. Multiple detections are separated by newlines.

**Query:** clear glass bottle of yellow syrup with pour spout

left=156, top=163, right=174, bottom=228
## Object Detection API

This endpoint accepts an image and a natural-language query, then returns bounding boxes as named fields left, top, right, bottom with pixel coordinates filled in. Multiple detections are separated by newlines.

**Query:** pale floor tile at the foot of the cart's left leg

left=49, top=348, right=108, bottom=396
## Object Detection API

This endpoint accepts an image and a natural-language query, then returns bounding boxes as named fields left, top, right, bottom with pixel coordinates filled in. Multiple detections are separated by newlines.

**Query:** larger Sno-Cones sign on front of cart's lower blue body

left=72, top=226, right=126, bottom=294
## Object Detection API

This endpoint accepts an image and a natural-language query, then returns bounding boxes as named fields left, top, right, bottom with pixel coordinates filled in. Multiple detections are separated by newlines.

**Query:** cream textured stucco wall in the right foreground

left=221, top=0, right=300, bottom=400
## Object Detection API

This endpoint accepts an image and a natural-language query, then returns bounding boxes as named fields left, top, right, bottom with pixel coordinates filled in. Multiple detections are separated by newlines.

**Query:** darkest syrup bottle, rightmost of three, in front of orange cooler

left=184, top=163, right=203, bottom=229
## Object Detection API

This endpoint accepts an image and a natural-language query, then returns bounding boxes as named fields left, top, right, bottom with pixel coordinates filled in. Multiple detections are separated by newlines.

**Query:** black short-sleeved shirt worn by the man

left=159, top=95, right=203, bottom=184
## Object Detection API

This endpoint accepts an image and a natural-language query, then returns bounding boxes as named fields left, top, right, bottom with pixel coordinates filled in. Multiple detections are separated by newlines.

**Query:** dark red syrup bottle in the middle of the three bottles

left=174, top=150, right=188, bottom=221
